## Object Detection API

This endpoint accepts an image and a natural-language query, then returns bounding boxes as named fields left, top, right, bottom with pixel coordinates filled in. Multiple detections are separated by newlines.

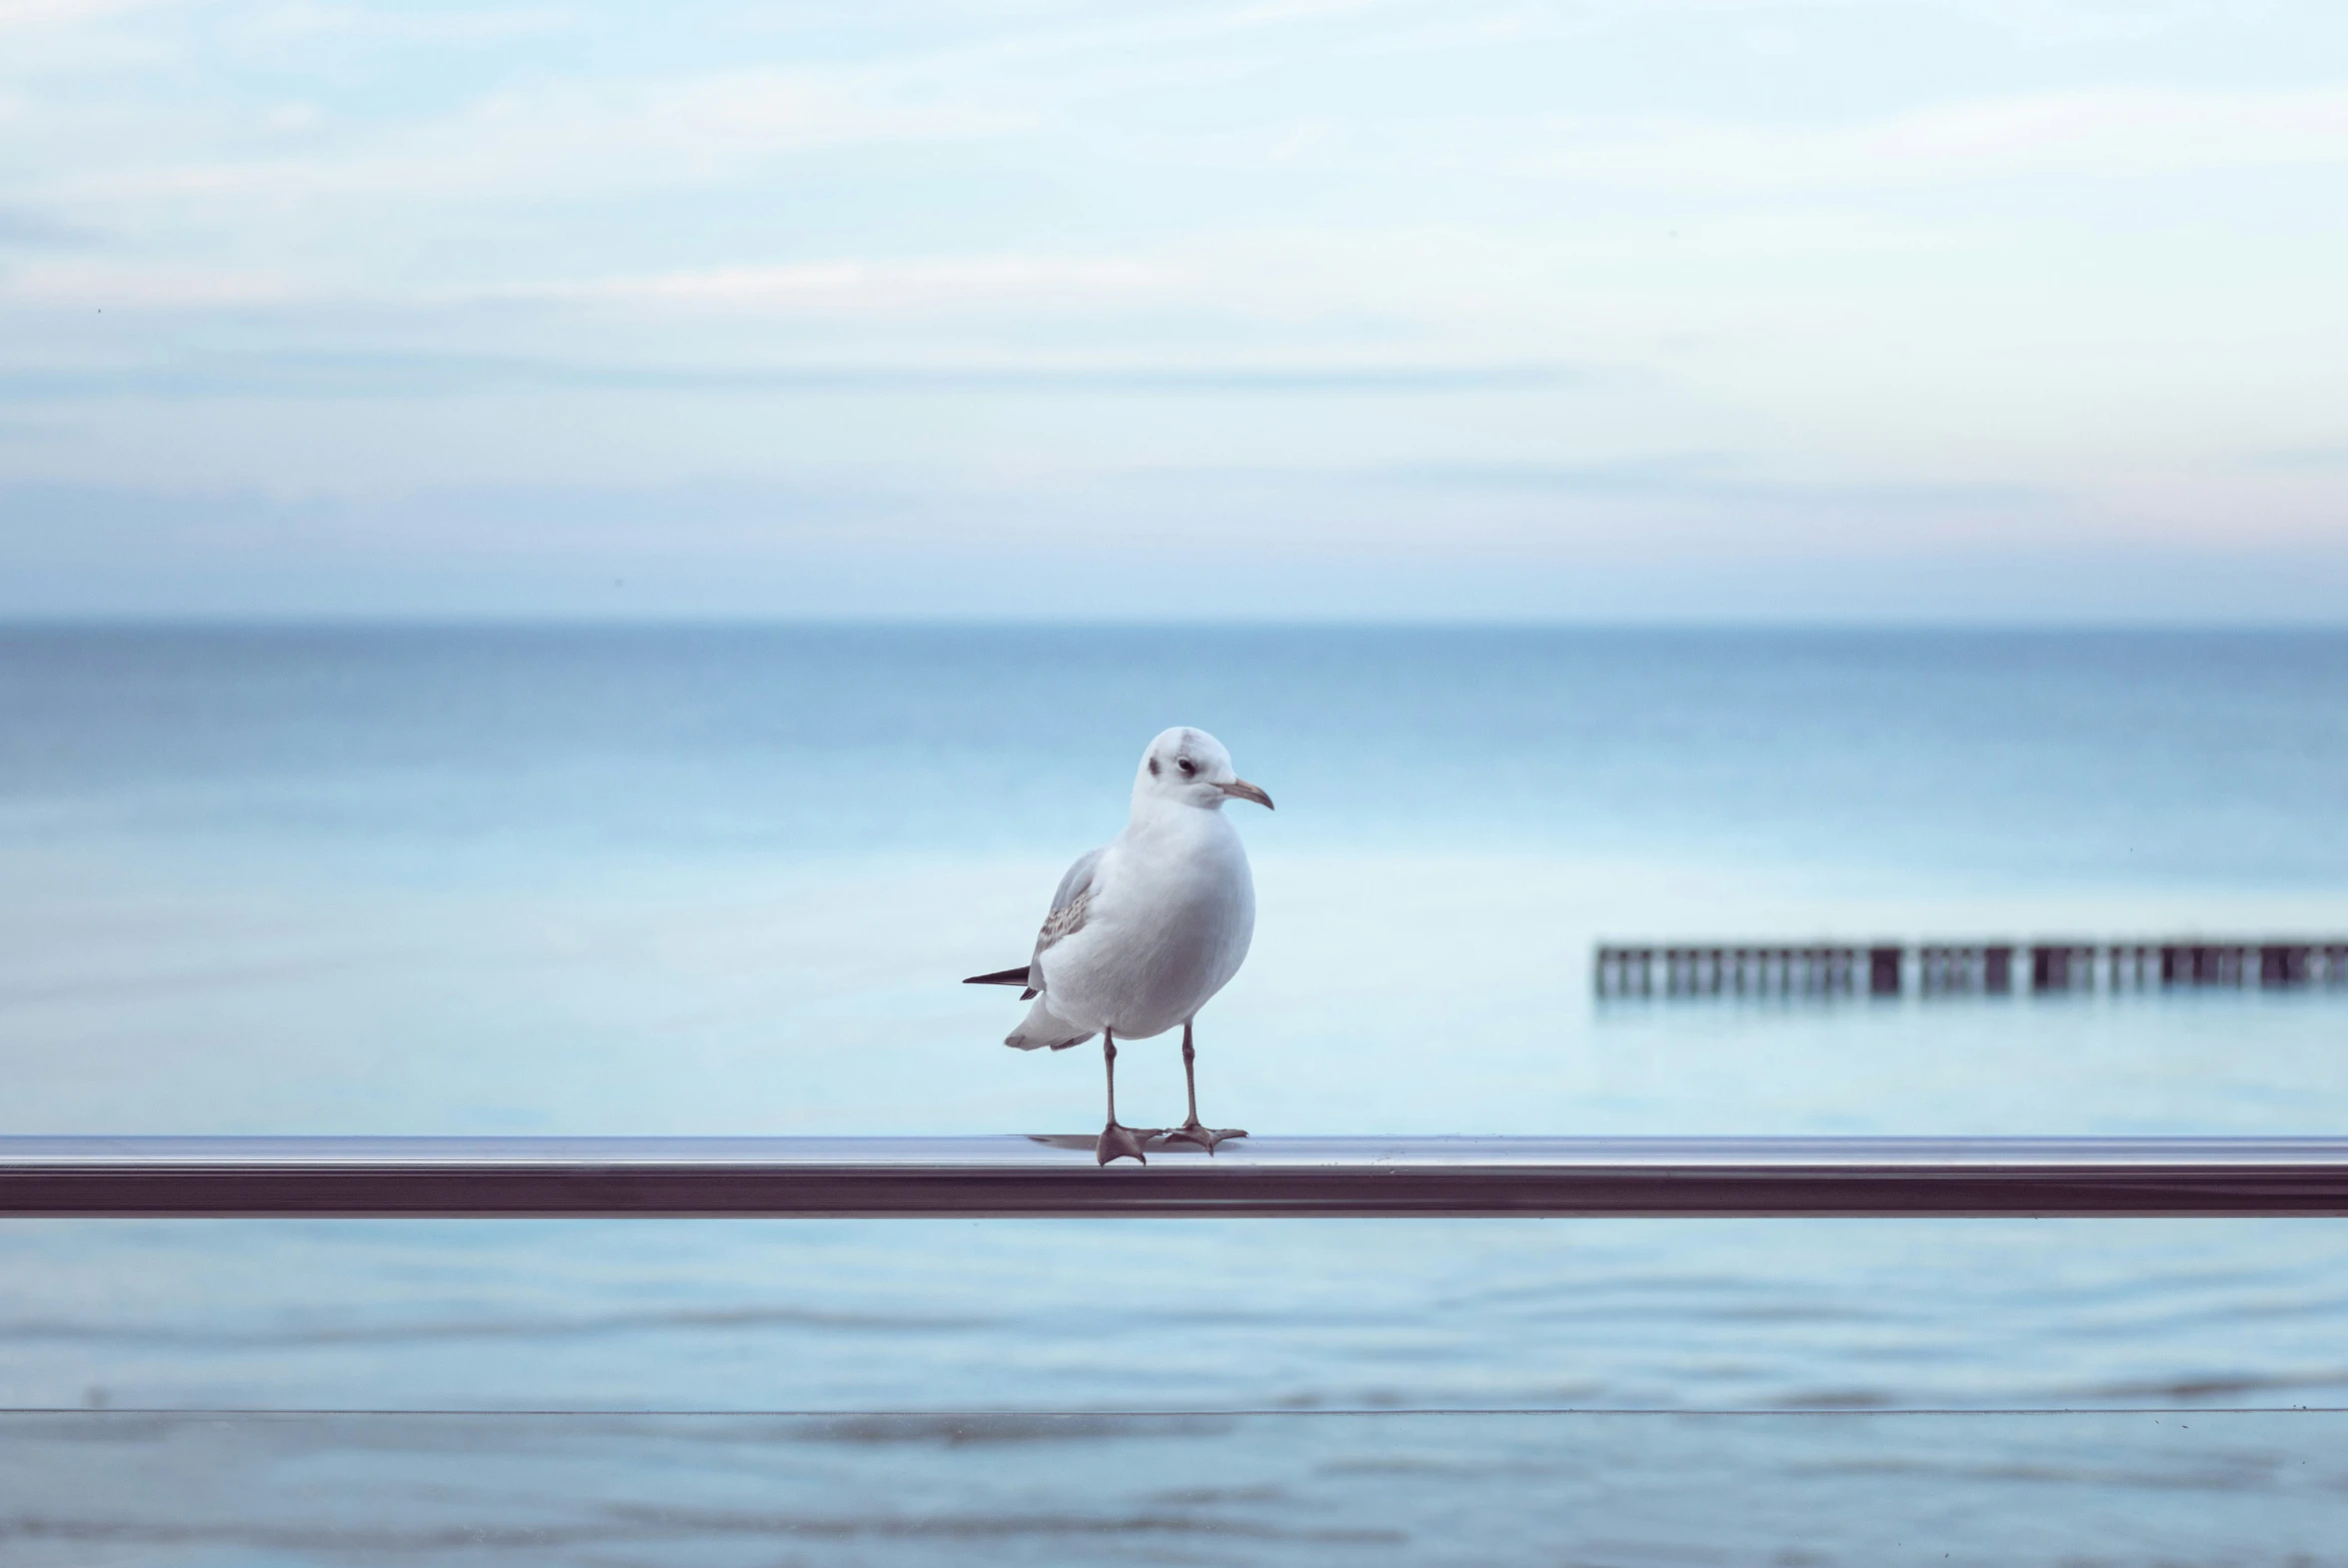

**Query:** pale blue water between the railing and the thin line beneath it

left=13, top=1220, right=2348, bottom=1411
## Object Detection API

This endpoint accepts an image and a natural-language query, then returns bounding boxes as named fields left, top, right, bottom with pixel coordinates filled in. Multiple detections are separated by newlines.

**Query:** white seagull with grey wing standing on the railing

left=963, top=728, right=1272, bottom=1164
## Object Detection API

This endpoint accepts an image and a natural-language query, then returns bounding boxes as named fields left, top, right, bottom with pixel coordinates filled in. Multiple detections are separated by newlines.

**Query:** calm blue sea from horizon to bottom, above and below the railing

left=0, top=625, right=2348, bottom=1568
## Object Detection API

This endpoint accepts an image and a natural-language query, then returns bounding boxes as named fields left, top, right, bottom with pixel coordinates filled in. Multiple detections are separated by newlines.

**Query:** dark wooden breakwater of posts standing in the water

left=1594, top=936, right=2348, bottom=997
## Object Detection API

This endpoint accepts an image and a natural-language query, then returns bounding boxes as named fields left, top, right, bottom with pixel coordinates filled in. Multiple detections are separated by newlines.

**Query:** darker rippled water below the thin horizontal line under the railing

left=0, top=1413, right=2348, bottom=1568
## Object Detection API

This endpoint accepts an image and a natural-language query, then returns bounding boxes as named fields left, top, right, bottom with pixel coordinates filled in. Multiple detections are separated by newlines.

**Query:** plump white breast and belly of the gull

left=1043, top=805, right=1256, bottom=1040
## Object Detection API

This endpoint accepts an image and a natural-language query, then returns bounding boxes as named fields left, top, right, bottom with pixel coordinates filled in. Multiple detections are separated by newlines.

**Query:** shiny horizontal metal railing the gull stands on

left=0, top=1133, right=2348, bottom=1218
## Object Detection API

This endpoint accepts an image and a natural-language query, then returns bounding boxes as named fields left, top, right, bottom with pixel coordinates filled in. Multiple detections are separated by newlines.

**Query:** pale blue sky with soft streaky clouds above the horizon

left=0, top=0, right=2348, bottom=625
